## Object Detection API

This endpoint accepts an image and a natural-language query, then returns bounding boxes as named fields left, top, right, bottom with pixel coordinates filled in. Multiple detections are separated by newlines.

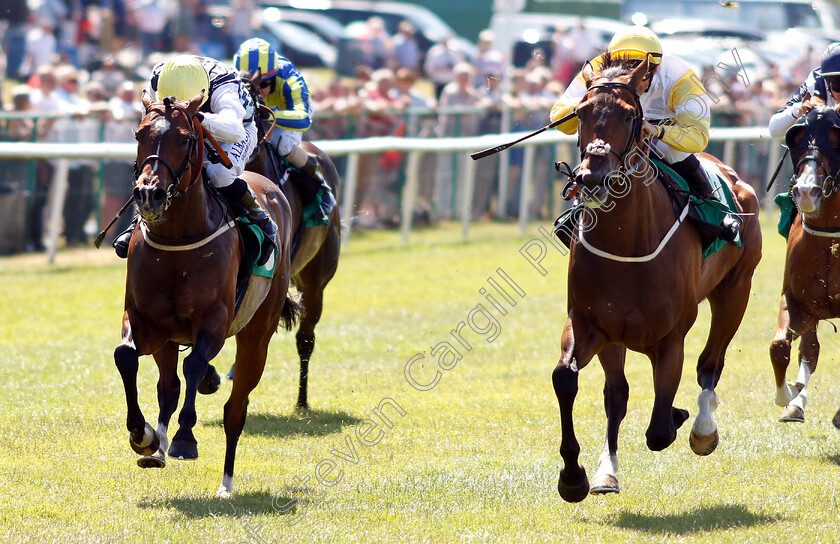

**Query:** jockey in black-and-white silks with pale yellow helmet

left=114, top=55, right=277, bottom=264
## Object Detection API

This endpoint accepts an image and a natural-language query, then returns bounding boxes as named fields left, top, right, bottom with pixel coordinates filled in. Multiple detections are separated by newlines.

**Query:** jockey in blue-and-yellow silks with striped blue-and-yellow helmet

left=233, top=38, right=335, bottom=226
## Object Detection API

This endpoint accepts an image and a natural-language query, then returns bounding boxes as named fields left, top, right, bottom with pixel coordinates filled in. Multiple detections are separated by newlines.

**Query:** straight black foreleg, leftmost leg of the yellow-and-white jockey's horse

left=551, top=310, right=605, bottom=502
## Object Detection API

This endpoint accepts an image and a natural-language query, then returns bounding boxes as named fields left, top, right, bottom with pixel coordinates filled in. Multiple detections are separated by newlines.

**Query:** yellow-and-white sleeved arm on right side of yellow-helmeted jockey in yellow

left=660, top=71, right=711, bottom=153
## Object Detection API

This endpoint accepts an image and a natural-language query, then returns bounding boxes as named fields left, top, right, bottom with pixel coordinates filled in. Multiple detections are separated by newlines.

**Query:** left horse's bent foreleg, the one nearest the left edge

left=114, top=310, right=160, bottom=455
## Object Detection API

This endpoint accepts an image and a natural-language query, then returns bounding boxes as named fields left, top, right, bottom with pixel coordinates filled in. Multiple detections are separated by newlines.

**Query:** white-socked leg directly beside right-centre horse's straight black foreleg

left=589, top=344, right=630, bottom=493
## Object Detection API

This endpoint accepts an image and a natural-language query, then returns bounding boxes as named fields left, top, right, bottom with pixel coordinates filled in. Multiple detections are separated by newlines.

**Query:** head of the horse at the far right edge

left=785, top=106, right=840, bottom=214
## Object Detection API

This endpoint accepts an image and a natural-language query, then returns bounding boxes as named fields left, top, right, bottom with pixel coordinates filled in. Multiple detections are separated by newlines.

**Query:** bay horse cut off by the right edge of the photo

left=770, top=105, right=840, bottom=428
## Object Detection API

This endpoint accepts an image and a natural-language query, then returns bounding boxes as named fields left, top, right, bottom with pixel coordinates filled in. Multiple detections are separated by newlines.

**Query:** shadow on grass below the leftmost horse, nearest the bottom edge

left=137, top=488, right=307, bottom=519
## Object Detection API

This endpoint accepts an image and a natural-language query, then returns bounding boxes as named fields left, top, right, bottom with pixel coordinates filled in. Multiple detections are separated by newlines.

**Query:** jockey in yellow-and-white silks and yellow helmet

left=551, top=26, right=716, bottom=199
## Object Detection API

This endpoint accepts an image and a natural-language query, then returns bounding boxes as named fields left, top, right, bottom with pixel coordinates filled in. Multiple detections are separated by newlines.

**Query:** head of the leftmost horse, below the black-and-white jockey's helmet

left=134, top=91, right=204, bottom=223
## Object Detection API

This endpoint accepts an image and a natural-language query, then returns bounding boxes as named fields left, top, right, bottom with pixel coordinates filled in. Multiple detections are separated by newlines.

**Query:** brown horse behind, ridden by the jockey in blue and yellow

left=235, top=72, right=341, bottom=409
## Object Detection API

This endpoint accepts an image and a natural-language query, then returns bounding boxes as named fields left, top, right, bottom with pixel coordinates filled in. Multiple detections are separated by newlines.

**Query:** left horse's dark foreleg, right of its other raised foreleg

left=169, top=319, right=226, bottom=460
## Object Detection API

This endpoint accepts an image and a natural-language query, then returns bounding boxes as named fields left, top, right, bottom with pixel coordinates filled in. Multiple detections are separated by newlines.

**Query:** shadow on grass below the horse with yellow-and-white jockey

left=611, top=504, right=778, bottom=534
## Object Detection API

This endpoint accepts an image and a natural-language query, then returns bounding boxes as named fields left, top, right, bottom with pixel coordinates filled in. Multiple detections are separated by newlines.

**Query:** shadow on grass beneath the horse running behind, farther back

left=213, top=410, right=361, bottom=438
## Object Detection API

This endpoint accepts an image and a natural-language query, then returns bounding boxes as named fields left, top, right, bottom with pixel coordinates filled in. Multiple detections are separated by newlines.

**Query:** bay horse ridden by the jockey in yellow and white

left=552, top=55, right=761, bottom=502
